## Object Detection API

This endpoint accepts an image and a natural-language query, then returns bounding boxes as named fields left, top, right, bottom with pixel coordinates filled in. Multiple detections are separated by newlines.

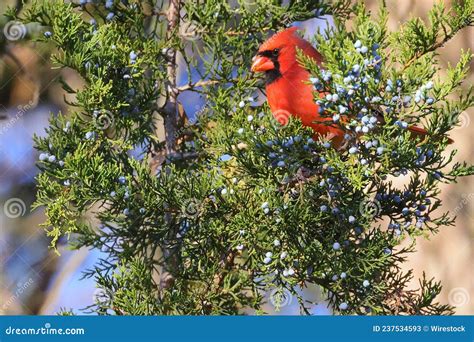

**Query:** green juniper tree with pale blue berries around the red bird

left=9, top=0, right=474, bottom=314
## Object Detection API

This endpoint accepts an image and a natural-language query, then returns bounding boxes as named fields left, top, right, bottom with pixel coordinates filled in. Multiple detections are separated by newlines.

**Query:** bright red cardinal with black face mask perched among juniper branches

left=251, top=27, right=446, bottom=147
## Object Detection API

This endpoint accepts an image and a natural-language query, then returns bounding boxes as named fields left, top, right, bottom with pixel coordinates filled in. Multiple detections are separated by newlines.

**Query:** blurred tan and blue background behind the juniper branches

left=0, top=0, right=474, bottom=315
